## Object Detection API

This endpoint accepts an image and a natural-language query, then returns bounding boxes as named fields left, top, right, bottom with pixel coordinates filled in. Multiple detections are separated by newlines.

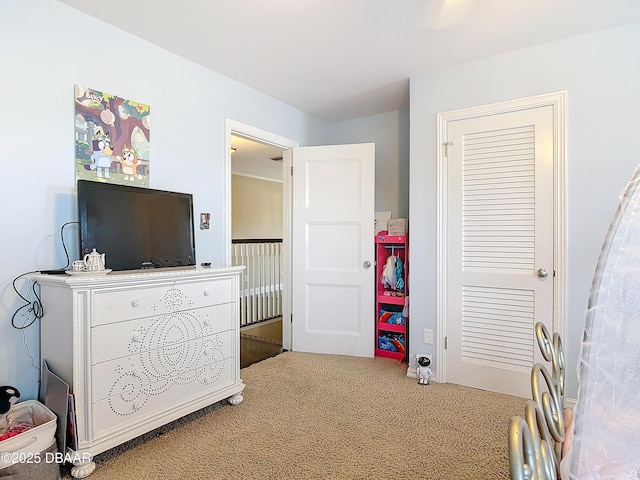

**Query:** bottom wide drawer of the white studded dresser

left=91, top=358, right=237, bottom=440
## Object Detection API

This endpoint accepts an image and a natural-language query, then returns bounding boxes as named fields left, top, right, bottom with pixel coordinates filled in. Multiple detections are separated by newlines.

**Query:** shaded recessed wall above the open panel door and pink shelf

left=327, top=110, right=409, bottom=218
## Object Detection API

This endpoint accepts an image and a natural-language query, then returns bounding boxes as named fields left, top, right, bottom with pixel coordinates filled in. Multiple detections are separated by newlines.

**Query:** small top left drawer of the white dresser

left=91, top=282, right=175, bottom=326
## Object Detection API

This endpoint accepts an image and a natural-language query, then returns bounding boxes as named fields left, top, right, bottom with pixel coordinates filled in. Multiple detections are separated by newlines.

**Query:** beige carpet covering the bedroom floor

left=75, top=352, right=524, bottom=480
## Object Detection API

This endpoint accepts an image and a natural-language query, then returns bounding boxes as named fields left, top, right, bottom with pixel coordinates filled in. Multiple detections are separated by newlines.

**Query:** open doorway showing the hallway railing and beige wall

left=227, top=121, right=297, bottom=368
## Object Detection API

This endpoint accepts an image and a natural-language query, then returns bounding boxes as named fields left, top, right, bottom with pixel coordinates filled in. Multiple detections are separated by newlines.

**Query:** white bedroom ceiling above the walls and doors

left=59, top=0, right=640, bottom=122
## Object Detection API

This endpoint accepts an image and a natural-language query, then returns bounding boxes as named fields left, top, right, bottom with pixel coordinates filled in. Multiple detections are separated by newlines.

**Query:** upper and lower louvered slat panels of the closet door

left=462, top=125, right=535, bottom=369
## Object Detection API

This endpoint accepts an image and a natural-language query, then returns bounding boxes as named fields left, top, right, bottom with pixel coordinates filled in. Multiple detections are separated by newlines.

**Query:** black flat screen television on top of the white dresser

left=78, top=180, right=196, bottom=270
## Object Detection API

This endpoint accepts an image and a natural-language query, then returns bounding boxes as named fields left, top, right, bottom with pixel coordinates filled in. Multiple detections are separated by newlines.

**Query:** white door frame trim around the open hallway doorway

left=224, top=118, right=299, bottom=350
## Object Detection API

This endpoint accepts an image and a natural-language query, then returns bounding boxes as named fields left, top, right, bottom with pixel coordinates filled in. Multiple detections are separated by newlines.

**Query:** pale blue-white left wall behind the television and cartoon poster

left=0, top=0, right=327, bottom=400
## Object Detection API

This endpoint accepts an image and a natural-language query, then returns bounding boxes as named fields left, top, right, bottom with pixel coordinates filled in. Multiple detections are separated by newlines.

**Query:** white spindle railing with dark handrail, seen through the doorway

left=231, top=240, right=282, bottom=327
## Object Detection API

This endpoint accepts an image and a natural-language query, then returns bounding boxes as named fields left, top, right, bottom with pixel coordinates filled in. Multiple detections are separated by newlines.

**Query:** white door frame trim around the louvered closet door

left=436, top=91, right=567, bottom=383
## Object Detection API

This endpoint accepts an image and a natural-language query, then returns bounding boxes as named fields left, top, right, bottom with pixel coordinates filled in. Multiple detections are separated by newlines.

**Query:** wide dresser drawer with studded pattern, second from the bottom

left=90, top=330, right=236, bottom=403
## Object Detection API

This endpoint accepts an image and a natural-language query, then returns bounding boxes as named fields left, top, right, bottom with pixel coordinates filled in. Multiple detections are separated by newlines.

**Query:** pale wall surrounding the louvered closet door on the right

left=409, top=24, right=640, bottom=398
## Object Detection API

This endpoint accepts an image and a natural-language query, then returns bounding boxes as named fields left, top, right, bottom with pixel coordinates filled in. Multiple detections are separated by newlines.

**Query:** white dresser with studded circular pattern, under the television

left=33, top=267, right=244, bottom=478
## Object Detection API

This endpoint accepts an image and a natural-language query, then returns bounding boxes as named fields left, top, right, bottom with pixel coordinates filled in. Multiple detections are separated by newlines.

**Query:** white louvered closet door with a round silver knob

left=446, top=105, right=555, bottom=397
